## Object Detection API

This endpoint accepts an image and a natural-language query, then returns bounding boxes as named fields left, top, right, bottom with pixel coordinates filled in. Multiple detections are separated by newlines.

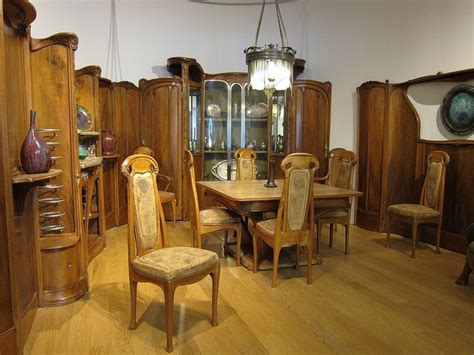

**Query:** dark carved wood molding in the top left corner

left=3, top=0, right=36, bottom=36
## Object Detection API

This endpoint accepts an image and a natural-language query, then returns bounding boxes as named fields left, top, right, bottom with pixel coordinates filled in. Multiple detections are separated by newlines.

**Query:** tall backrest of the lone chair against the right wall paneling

left=420, top=150, right=449, bottom=212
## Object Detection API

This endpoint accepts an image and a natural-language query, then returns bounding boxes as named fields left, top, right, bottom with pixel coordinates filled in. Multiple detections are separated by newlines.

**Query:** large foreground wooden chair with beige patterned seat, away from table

left=122, top=154, right=220, bottom=352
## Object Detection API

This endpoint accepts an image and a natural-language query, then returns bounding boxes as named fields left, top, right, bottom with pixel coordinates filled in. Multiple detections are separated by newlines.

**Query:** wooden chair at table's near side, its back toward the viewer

left=252, top=153, right=319, bottom=287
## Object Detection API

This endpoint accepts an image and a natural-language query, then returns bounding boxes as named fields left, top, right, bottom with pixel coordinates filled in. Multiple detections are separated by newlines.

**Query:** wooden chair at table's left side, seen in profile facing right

left=184, top=150, right=242, bottom=265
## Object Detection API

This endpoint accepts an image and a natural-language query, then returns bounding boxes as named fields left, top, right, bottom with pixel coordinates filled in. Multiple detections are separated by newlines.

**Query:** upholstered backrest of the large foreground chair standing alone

left=122, top=154, right=168, bottom=262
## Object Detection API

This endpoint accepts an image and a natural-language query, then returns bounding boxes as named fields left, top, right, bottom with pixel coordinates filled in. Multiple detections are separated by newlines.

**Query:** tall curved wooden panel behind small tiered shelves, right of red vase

left=30, top=33, right=88, bottom=305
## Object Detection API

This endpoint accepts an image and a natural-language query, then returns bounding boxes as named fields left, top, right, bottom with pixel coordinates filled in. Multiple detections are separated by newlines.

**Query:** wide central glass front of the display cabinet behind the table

left=203, top=79, right=269, bottom=180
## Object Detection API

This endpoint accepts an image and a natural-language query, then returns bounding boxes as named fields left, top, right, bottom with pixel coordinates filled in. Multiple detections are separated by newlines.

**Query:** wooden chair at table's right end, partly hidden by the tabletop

left=314, top=148, right=357, bottom=255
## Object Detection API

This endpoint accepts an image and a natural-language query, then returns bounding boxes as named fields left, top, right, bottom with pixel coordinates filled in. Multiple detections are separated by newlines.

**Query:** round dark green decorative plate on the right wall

left=441, top=84, right=474, bottom=136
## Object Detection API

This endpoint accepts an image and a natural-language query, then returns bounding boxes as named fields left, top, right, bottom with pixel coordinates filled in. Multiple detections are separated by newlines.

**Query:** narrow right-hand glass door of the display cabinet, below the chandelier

left=271, top=91, right=286, bottom=155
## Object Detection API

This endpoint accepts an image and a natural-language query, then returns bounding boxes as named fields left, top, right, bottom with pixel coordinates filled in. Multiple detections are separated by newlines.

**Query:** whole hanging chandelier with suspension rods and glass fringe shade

left=244, top=0, right=296, bottom=95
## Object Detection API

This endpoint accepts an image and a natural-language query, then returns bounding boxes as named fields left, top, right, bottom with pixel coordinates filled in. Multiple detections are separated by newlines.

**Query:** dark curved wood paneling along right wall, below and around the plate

left=356, top=69, right=474, bottom=253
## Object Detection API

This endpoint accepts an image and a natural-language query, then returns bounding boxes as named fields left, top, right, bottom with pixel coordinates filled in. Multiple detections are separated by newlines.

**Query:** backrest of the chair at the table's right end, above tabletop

left=327, top=148, right=357, bottom=189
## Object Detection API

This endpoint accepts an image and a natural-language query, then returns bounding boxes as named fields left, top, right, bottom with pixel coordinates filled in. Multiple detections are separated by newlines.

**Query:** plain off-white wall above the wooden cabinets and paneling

left=32, top=0, right=474, bottom=149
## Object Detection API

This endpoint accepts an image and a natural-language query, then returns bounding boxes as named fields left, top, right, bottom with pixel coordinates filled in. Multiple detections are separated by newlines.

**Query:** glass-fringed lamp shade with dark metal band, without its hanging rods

left=245, top=44, right=295, bottom=90
